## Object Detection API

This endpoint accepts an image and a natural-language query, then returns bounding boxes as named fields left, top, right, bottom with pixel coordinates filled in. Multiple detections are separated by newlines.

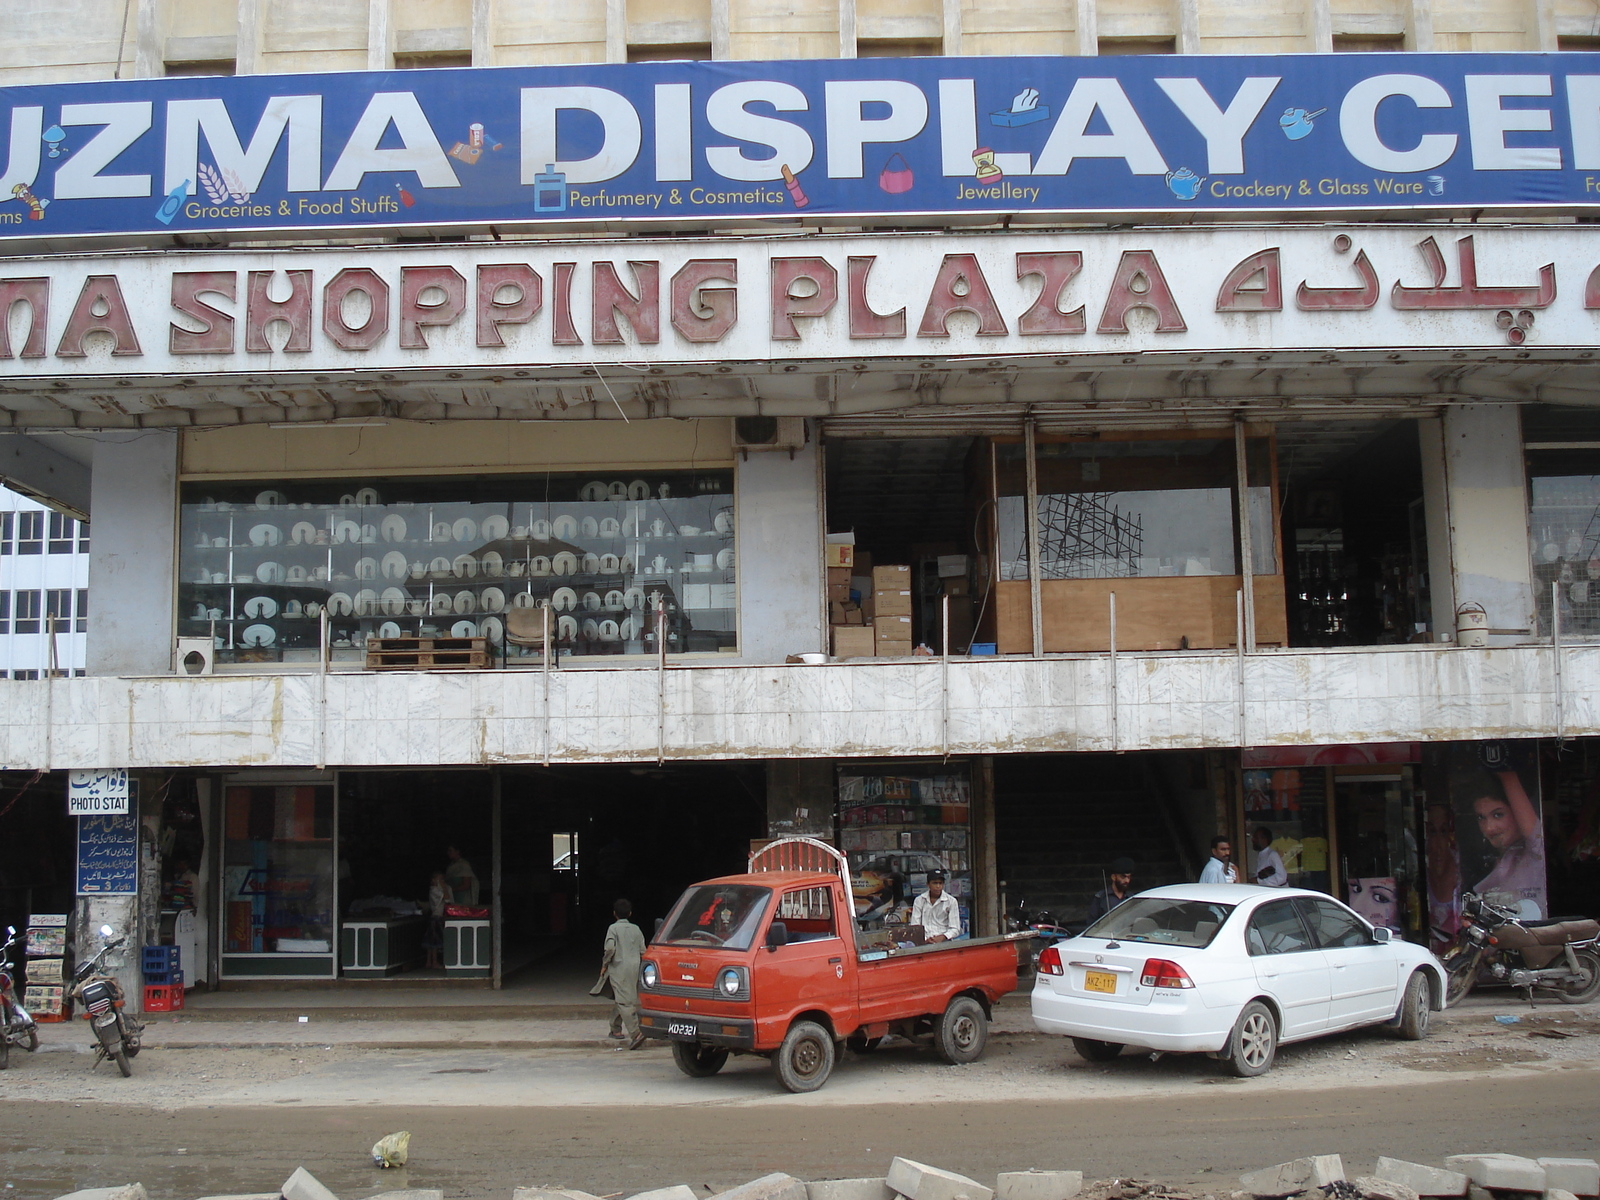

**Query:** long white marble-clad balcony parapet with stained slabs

left=0, top=643, right=1600, bottom=770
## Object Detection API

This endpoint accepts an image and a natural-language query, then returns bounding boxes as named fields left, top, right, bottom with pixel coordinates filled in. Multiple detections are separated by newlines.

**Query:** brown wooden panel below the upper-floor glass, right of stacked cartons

left=995, top=574, right=1288, bottom=654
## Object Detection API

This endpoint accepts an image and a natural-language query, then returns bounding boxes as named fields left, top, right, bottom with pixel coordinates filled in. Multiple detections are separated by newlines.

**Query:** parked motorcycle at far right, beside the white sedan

left=1445, top=891, right=1600, bottom=1005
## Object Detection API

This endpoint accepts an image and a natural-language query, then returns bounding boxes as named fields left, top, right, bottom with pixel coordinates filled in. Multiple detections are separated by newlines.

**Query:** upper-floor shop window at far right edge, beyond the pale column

left=1528, top=450, right=1600, bottom=637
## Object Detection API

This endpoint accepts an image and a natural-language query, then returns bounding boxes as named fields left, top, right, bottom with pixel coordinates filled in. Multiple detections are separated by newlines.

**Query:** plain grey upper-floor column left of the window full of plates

left=86, top=430, right=178, bottom=675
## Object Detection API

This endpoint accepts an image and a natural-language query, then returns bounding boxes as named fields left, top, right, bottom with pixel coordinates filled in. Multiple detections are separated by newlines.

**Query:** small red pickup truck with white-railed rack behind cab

left=638, top=838, right=1032, bottom=1091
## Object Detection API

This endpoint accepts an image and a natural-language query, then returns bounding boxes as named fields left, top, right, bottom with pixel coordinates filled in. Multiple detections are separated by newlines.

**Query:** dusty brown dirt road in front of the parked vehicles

left=9, top=1006, right=1600, bottom=1200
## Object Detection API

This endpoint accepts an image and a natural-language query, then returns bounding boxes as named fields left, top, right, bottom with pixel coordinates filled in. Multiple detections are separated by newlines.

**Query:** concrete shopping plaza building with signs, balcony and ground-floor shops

left=0, top=0, right=1600, bottom=1004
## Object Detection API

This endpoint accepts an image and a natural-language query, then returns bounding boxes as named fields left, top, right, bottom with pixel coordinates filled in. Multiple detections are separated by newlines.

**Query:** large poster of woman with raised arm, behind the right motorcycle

left=1446, top=741, right=1547, bottom=925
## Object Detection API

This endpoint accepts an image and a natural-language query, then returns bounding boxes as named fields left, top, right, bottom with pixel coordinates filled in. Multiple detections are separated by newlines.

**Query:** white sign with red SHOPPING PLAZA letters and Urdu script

left=0, top=224, right=1600, bottom=374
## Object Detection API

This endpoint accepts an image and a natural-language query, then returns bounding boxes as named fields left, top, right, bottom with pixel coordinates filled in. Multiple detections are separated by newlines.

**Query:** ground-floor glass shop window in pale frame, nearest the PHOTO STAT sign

left=222, top=786, right=336, bottom=955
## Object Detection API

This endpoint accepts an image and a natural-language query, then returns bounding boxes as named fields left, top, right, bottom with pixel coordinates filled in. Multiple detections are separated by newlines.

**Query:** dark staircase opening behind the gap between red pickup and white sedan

left=995, top=754, right=1189, bottom=923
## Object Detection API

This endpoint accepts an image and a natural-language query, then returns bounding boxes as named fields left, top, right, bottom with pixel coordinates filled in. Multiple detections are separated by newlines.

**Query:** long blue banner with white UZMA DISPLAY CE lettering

left=0, top=53, right=1600, bottom=240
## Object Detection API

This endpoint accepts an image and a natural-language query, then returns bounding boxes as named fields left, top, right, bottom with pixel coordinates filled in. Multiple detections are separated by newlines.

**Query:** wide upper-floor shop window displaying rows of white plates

left=178, top=470, right=738, bottom=662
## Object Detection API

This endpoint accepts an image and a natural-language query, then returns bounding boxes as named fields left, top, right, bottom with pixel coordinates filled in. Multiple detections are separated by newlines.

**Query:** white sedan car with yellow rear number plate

left=1034, top=883, right=1445, bottom=1075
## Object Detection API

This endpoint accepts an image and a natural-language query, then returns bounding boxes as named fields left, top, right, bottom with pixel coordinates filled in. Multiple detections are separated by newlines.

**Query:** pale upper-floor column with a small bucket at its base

left=1443, top=405, right=1536, bottom=645
